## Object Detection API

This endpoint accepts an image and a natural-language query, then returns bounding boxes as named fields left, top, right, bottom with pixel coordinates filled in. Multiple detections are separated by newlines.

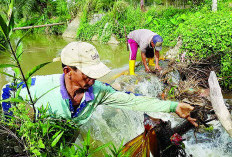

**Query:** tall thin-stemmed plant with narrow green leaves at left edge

left=0, top=0, right=50, bottom=122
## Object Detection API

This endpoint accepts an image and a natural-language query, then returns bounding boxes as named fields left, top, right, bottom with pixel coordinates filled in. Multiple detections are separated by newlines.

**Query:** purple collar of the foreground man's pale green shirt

left=60, top=74, right=94, bottom=102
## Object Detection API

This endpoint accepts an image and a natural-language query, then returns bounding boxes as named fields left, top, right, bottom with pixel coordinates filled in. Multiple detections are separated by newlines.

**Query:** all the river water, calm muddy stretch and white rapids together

left=0, top=35, right=232, bottom=157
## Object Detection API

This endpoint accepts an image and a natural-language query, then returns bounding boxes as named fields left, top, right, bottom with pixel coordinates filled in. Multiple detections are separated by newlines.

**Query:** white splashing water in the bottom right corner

left=184, top=121, right=232, bottom=157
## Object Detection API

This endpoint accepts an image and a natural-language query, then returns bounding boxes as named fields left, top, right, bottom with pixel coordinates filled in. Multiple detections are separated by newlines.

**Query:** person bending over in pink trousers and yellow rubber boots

left=127, top=29, right=163, bottom=75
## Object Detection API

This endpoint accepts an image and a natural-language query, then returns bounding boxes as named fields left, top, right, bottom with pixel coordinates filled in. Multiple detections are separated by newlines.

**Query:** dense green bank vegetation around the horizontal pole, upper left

left=0, top=0, right=71, bottom=34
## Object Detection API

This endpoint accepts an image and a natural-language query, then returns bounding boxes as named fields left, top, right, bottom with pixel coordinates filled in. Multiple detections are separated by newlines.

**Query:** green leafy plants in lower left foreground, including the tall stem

left=0, top=1, right=129, bottom=156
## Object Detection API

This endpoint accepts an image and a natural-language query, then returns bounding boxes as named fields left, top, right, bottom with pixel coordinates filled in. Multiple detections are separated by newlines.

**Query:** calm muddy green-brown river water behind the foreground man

left=0, top=35, right=170, bottom=88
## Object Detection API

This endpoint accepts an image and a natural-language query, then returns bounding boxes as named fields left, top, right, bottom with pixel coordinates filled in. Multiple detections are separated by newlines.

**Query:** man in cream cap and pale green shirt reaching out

left=2, top=42, right=197, bottom=125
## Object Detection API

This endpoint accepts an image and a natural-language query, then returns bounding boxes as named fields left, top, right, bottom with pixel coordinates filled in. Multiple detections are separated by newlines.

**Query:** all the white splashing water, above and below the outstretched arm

left=76, top=73, right=232, bottom=157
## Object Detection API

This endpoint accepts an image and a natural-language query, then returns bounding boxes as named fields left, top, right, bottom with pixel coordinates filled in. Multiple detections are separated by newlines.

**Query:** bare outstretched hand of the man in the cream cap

left=176, top=103, right=198, bottom=127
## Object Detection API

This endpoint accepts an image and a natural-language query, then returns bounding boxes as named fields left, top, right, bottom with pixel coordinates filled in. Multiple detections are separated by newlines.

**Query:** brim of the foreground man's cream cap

left=77, top=62, right=111, bottom=79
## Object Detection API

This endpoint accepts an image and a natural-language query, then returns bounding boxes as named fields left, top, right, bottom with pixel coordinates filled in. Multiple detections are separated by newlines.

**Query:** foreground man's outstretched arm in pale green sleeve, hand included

left=101, top=91, right=197, bottom=126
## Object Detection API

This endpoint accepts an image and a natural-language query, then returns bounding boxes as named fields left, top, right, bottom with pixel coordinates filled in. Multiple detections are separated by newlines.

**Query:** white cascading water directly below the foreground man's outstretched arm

left=76, top=106, right=177, bottom=146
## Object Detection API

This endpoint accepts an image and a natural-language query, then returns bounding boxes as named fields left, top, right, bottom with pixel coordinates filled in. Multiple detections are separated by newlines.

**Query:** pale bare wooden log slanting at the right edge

left=208, top=71, right=232, bottom=137
